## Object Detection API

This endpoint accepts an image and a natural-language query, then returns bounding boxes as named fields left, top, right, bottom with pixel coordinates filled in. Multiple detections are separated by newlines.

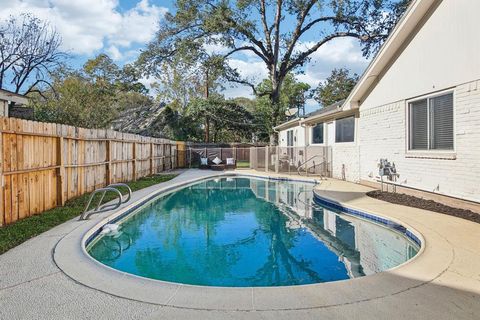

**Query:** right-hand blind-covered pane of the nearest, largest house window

left=430, top=93, right=453, bottom=150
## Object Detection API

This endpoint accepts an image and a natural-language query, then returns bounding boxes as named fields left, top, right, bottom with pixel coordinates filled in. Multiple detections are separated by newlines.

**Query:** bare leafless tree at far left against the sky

left=0, top=14, right=66, bottom=94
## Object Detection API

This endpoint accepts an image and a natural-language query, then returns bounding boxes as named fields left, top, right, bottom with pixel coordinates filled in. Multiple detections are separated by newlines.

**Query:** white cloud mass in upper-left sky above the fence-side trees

left=0, top=0, right=167, bottom=60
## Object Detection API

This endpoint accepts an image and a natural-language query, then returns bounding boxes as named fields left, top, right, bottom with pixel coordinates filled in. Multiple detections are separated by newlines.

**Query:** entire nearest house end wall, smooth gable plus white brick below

left=359, top=0, right=480, bottom=202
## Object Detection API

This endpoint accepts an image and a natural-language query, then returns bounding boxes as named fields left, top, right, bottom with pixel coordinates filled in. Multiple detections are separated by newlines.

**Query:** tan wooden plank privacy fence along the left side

left=0, top=117, right=177, bottom=226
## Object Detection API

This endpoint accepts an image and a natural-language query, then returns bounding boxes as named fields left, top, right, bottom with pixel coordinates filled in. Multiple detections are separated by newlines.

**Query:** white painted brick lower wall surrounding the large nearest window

left=360, top=81, right=480, bottom=201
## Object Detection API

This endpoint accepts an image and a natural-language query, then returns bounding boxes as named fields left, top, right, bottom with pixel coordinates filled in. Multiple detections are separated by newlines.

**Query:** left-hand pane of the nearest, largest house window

left=410, top=99, right=428, bottom=150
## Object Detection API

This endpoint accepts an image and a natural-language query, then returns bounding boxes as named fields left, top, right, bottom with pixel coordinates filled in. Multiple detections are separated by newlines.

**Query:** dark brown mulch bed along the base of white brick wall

left=367, top=190, right=480, bottom=223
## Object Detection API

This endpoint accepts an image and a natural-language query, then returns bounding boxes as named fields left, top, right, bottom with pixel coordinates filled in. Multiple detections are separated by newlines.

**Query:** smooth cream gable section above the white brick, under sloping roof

left=361, top=0, right=480, bottom=109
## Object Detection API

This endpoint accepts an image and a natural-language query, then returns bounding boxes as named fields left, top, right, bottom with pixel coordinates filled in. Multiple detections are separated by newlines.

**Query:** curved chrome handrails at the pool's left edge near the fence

left=79, top=183, right=132, bottom=220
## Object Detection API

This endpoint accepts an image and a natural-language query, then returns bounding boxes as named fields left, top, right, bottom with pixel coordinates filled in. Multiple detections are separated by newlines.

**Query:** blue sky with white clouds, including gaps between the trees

left=0, top=0, right=368, bottom=111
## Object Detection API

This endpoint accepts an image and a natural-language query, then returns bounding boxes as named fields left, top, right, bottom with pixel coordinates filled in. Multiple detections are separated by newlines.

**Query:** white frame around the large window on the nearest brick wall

left=405, top=88, right=457, bottom=160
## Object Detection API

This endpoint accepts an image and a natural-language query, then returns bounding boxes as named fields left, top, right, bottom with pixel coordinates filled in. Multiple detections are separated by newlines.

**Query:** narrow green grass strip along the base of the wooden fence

left=0, top=174, right=176, bottom=254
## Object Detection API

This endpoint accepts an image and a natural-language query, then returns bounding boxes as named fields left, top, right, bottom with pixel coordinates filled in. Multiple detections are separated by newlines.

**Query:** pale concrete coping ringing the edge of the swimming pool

left=53, top=171, right=453, bottom=311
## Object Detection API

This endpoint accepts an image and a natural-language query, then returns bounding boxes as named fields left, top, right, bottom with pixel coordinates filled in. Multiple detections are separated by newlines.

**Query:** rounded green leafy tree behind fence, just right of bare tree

left=32, top=54, right=153, bottom=130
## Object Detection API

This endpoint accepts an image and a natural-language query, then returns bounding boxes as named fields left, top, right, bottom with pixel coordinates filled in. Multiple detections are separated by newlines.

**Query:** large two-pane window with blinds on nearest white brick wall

left=409, top=93, right=453, bottom=150
